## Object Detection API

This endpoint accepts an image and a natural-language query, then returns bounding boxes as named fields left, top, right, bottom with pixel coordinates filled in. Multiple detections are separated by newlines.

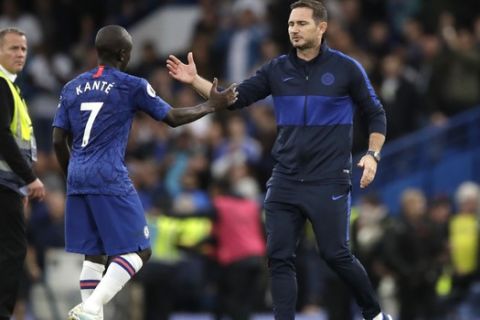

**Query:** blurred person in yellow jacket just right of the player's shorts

left=136, top=206, right=212, bottom=320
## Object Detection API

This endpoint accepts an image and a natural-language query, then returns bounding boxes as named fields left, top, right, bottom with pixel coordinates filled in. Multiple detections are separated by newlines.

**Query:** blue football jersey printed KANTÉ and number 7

left=53, top=66, right=171, bottom=195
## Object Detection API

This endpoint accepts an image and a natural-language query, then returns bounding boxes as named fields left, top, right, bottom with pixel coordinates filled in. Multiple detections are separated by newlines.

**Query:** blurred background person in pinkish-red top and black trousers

left=211, top=180, right=266, bottom=320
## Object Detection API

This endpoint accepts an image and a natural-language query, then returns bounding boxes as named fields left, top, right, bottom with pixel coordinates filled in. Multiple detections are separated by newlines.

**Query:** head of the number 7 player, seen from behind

left=95, top=25, right=132, bottom=70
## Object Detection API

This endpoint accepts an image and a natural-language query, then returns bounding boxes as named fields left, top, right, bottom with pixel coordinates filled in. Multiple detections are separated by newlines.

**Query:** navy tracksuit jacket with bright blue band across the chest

left=230, top=42, right=386, bottom=183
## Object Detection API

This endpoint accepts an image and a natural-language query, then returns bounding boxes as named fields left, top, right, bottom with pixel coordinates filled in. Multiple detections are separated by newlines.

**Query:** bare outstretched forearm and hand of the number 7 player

left=163, top=78, right=238, bottom=127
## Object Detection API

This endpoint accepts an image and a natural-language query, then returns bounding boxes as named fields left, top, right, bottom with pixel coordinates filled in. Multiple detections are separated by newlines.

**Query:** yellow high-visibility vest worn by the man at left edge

left=0, top=71, right=37, bottom=194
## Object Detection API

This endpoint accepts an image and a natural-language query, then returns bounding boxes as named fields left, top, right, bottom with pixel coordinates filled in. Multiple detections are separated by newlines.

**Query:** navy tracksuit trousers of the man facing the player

left=265, top=178, right=380, bottom=320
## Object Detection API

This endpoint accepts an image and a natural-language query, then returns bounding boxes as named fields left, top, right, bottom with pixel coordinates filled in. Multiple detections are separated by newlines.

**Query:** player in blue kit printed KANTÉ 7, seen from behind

left=53, top=25, right=237, bottom=320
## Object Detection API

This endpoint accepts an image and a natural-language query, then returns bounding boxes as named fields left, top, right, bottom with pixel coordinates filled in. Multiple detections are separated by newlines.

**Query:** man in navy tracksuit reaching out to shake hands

left=167, top=0, right=391, bottom=320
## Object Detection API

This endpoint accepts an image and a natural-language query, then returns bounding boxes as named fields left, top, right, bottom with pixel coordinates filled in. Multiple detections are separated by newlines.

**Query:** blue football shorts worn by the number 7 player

left=65, top=194, right=150, bottom=256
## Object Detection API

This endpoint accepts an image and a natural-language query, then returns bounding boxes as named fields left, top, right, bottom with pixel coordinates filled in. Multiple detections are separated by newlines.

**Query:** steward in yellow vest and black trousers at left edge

left=0, top=28, right=45, bottom=320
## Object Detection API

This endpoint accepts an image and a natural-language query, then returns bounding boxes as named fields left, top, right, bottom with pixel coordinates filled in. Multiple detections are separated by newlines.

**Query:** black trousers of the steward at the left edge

left=0, top=186, right=27, bottom=320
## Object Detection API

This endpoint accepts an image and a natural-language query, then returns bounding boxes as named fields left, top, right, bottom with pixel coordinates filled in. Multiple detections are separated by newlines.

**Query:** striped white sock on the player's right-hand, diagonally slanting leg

left=83, top=253, right=143, bottom=314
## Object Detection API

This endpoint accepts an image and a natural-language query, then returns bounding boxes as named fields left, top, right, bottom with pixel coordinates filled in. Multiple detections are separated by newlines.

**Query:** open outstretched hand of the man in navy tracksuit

left=167, top=52, right=212, bottom=99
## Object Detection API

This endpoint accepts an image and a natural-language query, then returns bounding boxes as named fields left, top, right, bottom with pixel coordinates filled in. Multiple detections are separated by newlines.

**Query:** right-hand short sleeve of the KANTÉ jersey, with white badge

left=133, top=79, right=172, bottom=121
